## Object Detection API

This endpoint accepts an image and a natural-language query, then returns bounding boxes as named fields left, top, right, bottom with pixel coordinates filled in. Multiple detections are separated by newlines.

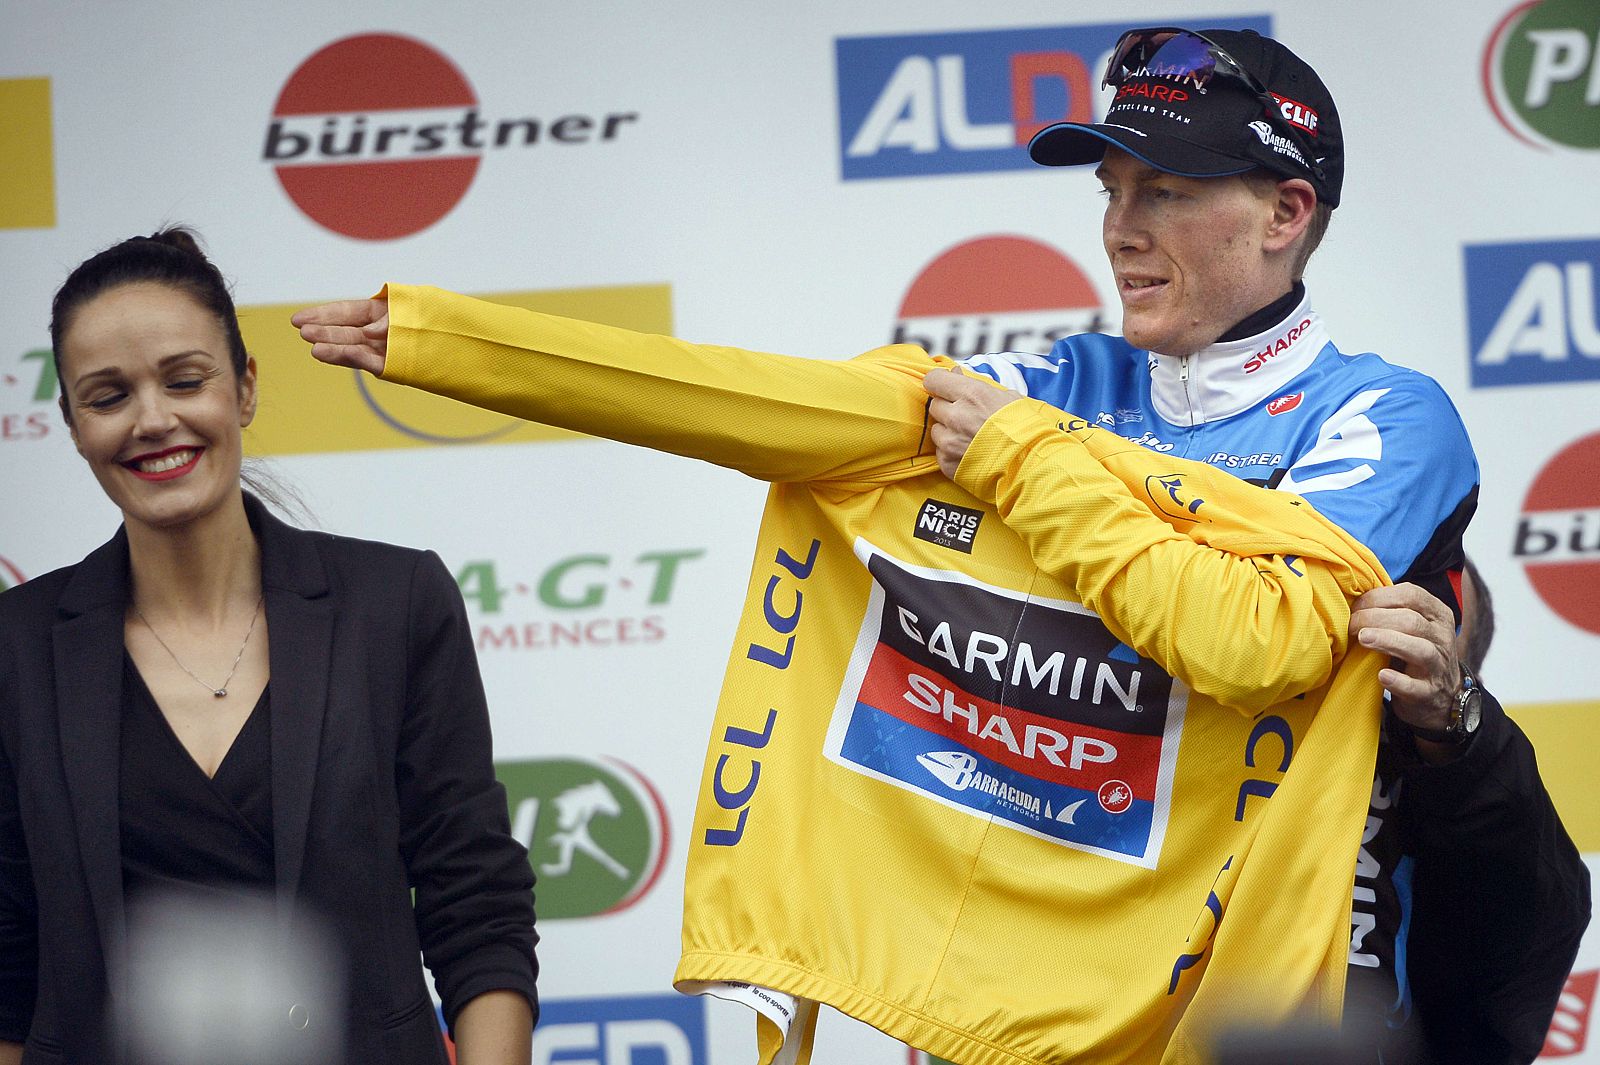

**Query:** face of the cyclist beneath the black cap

left=1096, top=149, right=1288, bottom=355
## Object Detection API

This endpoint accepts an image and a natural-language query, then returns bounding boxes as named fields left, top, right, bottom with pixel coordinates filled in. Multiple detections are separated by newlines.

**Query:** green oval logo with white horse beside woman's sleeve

left=494, top=758, right=669, bottom=921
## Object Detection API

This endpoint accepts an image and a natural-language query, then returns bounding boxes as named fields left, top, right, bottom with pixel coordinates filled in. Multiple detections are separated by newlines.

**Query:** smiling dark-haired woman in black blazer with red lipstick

left=0, top=229, right=538, bottom=1065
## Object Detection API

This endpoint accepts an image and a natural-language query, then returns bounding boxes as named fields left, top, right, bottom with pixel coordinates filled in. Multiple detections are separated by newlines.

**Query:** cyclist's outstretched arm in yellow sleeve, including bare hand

left=294, top=285, right=949, bottom=485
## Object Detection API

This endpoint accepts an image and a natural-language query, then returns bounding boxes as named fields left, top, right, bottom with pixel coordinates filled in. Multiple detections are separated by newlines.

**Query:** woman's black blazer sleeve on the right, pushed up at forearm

left=395, top=552, right=539, bottom=1030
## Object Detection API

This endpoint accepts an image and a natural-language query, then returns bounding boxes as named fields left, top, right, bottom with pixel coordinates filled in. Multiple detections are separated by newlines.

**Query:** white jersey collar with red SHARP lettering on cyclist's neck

left=1150, top=296, right=1328, bottom=425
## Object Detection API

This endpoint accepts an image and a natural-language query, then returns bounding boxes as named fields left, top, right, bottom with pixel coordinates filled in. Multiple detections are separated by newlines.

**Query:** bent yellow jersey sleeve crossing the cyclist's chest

left=955, top=400, right=1387, bottom=713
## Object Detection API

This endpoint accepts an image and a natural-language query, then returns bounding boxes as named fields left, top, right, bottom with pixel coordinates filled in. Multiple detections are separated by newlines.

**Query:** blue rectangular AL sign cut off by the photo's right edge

left=1466, top=240, right=1600, bottom=389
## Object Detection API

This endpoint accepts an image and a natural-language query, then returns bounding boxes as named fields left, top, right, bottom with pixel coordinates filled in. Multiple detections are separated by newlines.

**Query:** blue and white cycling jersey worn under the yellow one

left=966, top=291, right=1478, bottom=588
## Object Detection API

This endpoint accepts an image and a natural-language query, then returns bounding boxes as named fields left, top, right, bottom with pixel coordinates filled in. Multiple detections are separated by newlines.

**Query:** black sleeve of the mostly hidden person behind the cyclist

left=1400, top=692, right=1589, bottom=1065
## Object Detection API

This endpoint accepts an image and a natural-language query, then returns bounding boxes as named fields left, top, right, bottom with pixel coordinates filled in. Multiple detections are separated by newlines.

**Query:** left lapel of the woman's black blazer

left=51, top=531, right=128, bottom=991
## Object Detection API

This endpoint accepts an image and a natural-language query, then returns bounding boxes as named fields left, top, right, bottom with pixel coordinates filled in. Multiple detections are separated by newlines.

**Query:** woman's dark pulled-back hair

left=50, top=225, right=248, bottom=425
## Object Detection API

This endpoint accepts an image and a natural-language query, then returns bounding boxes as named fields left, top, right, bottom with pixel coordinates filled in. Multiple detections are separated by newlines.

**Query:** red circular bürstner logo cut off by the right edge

left=1512, top=433, right=1600, bottom=635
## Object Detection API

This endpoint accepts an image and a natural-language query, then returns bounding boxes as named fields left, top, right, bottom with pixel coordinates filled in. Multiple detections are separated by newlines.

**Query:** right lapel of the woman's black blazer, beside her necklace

left=245, top=496, right=333, bottom=916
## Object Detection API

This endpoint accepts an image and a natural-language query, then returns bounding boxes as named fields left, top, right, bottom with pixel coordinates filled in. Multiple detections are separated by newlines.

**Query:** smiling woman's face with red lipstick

left=61, top=283, right=256, bottom=528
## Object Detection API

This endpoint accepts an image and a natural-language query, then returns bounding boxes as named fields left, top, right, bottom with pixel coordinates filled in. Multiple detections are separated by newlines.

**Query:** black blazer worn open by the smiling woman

left=0, top=496, right=538, bottom=1065
